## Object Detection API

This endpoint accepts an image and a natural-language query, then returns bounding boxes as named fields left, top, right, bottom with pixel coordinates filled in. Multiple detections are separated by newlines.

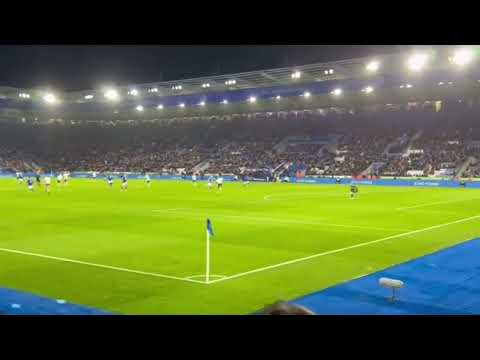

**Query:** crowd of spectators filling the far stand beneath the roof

left=0, top=100, right=480, bottom=176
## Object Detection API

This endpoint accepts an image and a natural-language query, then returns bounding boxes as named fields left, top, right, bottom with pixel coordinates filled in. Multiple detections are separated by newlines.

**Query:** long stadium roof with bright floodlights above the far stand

left=0, top=47, right=478, bottom=104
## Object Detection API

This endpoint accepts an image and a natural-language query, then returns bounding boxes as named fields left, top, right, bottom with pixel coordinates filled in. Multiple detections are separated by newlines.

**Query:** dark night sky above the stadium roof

left=0, top=45, right=411, bottom=90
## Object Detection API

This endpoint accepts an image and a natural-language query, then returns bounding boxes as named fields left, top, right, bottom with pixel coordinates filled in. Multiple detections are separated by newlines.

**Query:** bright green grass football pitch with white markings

left=0, top=179, right=480, bottom=314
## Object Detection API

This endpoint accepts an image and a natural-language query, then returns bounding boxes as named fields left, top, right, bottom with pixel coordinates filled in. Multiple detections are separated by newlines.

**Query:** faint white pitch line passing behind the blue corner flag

left=152, top=210, right=411, bottom=231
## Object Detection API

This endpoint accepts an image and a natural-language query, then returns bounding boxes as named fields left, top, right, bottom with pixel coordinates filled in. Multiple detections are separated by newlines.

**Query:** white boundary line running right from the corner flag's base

left=210, top=215, right=480, bottom=284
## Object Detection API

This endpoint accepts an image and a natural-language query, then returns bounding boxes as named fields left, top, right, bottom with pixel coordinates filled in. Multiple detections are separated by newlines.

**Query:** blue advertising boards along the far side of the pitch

left=0, top=172, right=480, bottom=189
